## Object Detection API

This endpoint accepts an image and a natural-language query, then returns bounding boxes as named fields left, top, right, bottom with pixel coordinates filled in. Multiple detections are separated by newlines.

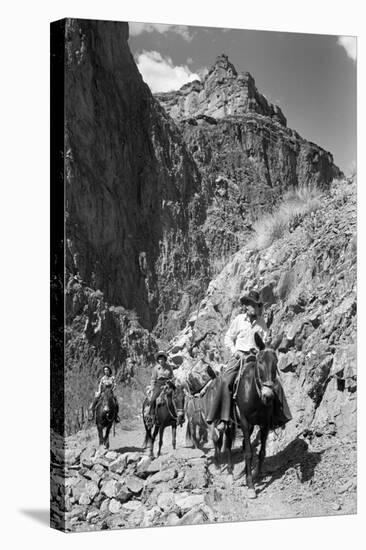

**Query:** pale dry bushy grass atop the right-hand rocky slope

left=251, top=187, right=321, bottom=250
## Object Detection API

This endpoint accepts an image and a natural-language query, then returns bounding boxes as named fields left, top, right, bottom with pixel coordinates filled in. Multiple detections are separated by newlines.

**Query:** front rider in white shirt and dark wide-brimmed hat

left=207, top=290, right=268, bottom=435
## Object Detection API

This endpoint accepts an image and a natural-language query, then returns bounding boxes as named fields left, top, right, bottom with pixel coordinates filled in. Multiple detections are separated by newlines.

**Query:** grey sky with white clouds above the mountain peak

left=129, top=23, right=357, bottom=174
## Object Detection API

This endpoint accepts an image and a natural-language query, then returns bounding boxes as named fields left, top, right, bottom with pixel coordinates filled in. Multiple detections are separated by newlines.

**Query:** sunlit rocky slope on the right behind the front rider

left=171, top=183, right=357, bottom=451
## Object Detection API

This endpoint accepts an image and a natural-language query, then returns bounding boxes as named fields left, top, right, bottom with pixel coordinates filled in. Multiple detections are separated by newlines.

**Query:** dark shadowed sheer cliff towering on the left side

left=65, top=20, right=207, bottom=328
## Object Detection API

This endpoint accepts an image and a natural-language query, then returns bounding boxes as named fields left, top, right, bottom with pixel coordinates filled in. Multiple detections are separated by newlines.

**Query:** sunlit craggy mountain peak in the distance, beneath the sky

left=156, top=55, right=342, bottom=273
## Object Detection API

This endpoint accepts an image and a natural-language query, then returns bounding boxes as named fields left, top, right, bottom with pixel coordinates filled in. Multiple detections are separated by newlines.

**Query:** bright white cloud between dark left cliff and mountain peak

left=136, top=51, right=200, bottom=93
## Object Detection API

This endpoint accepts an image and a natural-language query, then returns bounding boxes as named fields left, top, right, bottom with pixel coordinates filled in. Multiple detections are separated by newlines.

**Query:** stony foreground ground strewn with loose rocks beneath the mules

left=51, top=418, right=356, bottom=531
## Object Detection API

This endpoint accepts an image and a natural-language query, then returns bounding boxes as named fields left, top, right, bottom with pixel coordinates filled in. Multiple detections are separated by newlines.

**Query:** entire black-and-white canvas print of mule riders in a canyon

left=50, top=17, right=357, bottom=536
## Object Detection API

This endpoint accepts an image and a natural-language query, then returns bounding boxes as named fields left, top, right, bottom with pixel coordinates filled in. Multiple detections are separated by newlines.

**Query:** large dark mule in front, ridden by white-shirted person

left=225, top=335, right=277, bottom=498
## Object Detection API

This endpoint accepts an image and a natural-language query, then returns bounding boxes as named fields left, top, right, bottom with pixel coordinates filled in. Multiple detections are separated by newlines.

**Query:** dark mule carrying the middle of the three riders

left=142, top=382, right=184, bottom=458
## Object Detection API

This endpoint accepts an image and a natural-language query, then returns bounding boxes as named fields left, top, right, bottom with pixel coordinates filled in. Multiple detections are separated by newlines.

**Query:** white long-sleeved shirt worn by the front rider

left=224, top=313, right=268, bottom=354
